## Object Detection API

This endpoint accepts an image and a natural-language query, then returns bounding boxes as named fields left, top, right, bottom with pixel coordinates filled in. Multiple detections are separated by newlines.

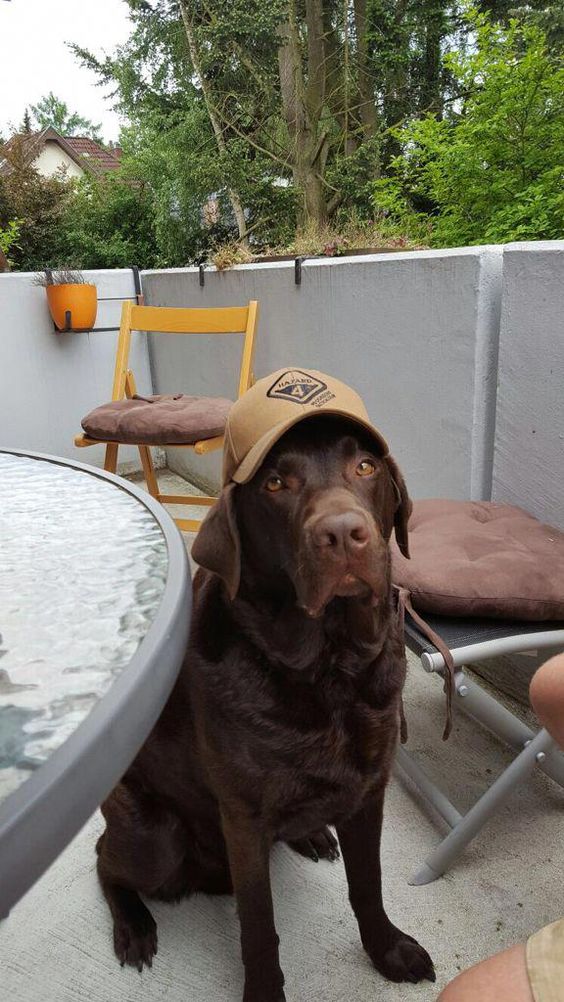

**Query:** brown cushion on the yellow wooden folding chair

left=81, top=393, right=232, bottom=445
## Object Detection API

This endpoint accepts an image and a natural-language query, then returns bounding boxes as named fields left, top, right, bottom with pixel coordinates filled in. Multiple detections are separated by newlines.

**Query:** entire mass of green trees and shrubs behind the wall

left=4, top=0, right=564, bottom=271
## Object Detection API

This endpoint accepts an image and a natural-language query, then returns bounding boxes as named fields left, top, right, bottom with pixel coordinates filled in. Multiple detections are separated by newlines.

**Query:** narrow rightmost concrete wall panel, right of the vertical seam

left=493, top=240, right=564, bottom=529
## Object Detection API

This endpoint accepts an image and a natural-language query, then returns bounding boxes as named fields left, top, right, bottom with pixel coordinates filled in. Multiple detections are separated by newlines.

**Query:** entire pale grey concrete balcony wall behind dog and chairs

left=0, top=241, right=564, bottom=528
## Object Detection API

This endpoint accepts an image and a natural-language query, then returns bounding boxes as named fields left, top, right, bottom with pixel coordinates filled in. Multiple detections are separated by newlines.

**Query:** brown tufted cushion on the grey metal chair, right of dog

left=392, top=499, right=564, bottom=620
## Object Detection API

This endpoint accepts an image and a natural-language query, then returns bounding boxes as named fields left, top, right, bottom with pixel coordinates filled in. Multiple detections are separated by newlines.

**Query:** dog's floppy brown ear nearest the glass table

left=192, top=484, right=240, bottom=601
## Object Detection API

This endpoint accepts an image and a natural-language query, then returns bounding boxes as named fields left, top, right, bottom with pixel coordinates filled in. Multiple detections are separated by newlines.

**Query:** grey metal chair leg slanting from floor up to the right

left=409, top=728, right=555, bottom=885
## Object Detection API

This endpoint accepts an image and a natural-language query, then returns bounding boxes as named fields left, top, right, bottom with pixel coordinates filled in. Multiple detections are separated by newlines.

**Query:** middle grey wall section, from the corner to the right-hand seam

left=143, top=247, right=502, bottom=498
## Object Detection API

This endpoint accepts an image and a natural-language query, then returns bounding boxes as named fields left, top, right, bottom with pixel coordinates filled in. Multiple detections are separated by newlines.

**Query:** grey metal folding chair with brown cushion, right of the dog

left=394, top=501, right=564, bottom=884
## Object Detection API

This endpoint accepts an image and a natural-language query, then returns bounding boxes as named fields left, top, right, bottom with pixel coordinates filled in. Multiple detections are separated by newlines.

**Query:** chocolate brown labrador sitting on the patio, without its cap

left=97, top=415, right=435, bottom=1002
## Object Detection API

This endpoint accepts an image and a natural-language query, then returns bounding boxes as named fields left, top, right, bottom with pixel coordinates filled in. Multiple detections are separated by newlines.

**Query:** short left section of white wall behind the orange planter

left=0, top=270, right=151, bottom=466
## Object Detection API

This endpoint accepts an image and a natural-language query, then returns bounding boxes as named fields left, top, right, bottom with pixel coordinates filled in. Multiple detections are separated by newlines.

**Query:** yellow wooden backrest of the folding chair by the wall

left=112, top=300, right=258, bottom=400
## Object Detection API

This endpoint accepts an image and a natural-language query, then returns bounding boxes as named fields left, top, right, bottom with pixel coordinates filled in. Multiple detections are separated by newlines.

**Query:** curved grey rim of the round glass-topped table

left=0, top=446, right=191, bottom=919
